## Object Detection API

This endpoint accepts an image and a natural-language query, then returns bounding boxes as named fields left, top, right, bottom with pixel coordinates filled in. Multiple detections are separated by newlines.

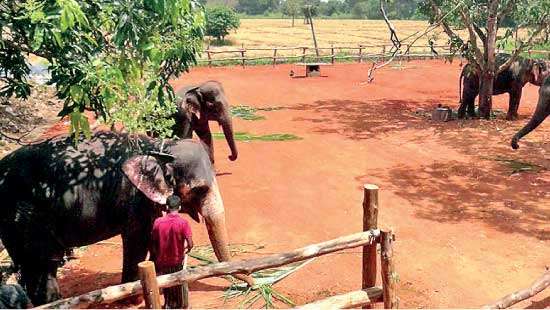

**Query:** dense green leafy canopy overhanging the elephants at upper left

left=0, top=0, right=204, bottom=135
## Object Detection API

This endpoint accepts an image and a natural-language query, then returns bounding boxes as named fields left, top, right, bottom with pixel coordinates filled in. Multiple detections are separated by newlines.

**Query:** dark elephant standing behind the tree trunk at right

left=458, top=54, right=546, bottom=120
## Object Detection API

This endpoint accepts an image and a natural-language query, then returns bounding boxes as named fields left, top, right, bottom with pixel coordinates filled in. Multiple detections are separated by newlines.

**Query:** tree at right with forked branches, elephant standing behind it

left=423, top=0, right=550, bottom=119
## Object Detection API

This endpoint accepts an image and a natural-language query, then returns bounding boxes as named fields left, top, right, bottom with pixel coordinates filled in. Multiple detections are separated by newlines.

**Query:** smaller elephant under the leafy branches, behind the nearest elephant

left=173, top=81, right=238, bottom=163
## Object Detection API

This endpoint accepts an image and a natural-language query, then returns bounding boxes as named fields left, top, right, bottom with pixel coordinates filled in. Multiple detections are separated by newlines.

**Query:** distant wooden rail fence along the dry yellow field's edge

left=198, top=44, right=450, bottom=67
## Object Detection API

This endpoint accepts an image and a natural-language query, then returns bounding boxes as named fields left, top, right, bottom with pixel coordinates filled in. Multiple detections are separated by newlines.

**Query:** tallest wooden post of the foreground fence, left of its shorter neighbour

left=362, top=184, right=378, bottom=308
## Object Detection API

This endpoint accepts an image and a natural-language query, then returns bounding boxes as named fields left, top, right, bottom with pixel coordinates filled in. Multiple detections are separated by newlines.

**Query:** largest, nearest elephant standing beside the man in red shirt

left=0, top=132, right=252, bottom=305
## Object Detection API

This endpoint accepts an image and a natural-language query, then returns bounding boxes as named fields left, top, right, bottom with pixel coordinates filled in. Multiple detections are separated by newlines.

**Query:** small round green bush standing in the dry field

left=206, top=6, right=241, bottom=41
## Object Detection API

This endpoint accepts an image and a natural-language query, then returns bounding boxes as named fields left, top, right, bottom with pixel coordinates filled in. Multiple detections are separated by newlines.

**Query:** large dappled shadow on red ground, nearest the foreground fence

left=357, top=161, right=550, bottom=240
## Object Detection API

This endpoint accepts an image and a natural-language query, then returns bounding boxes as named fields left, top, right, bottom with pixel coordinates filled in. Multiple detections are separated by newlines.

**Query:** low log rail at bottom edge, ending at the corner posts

left=297, top=286, right=382, bottom=310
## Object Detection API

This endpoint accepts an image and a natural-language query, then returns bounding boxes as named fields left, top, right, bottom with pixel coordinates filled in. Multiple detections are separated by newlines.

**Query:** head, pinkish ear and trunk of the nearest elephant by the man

left=122, top=140, right=253, bottom=285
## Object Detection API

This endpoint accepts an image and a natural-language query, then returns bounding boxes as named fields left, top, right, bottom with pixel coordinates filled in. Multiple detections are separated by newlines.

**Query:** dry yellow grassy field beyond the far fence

left=202, top=18, right=546, bottom=64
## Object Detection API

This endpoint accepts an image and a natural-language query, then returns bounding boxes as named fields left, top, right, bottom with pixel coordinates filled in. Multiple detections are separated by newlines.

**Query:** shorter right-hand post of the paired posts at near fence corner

left=380, top=230, right=399, bottom=309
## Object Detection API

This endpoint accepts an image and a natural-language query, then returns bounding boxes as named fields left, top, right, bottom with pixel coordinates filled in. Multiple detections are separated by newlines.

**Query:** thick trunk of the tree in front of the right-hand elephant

left=479, top=0, right=500, bottom=119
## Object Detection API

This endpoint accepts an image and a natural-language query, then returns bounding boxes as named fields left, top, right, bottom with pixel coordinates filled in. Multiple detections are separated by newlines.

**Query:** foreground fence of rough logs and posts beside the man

left=39, top=184, right=399, bottom=309
